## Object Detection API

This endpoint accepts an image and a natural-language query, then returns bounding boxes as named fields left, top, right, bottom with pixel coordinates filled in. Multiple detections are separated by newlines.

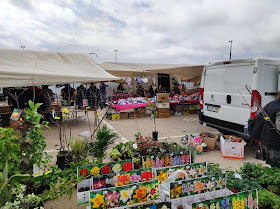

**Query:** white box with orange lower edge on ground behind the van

left=220, top=136, right=246, bottom=160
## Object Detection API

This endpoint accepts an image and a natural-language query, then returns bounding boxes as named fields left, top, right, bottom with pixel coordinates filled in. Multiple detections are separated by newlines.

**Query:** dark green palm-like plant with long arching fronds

left=92, top=125, right=119, bottom=163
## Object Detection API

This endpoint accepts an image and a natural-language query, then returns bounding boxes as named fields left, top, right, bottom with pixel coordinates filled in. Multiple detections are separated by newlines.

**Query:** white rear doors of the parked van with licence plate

left=203, top=62, right=256, bottom=125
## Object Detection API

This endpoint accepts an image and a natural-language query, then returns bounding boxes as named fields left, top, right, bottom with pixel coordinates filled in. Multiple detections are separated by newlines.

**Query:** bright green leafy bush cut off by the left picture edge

left=0, top=127, right=21, bottom=175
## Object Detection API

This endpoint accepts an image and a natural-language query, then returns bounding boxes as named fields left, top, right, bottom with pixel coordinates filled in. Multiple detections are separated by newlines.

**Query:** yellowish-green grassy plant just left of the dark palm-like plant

left=69, top=138, right=89, bottom=162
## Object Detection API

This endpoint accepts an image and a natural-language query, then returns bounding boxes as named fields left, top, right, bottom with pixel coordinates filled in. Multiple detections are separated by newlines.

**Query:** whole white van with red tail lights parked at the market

left=199, top=58, right=280, bottom=139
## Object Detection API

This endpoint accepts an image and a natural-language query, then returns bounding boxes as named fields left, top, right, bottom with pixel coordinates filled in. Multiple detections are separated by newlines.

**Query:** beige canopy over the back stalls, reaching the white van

left=102, top=62, right=203, bottom=79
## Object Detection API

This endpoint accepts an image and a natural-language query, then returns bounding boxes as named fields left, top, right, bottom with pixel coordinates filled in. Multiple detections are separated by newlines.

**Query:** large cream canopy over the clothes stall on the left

left=0, top=49, right=119, bottom=87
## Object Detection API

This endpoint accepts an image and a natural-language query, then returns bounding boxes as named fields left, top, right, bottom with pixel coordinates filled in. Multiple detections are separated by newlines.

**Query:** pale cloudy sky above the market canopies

left=0, top=0, right=280, bottom=64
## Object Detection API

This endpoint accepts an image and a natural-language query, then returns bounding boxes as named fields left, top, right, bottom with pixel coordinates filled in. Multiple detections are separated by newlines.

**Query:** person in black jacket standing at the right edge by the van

left=251, top=91, right=280, bottom=167
